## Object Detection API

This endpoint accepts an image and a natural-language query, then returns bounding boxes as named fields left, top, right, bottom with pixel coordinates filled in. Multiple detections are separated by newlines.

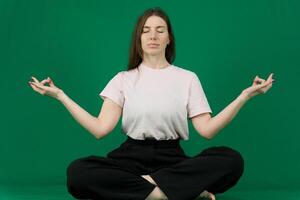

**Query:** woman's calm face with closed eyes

left=141, top=16, right=170, bottom=55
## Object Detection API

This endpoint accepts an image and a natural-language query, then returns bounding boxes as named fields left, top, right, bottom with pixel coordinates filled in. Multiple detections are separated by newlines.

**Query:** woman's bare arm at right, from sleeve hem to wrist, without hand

left=192, top=93, right=247, bottom=139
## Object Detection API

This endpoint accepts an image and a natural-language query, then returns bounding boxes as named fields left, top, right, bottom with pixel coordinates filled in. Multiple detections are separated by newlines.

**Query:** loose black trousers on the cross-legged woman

left=67, top=137, right=244, bottom=200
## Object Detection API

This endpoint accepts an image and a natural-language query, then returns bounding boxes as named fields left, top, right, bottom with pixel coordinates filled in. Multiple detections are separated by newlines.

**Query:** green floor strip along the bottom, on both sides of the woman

left=0, top=185, right=300, bottom=200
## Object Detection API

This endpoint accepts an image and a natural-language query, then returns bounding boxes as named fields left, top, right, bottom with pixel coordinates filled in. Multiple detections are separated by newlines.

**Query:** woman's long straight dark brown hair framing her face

left=127, top=7, right=175, bottom=70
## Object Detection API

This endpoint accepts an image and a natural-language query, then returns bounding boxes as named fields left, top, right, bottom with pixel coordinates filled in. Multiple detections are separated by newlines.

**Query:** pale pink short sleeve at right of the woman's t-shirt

left=187, top=73, right=212, bottom=118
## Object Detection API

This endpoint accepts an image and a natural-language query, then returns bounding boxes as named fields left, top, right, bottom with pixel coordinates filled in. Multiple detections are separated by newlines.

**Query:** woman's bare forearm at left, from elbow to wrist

left=57, top=92, right=99, bottom=138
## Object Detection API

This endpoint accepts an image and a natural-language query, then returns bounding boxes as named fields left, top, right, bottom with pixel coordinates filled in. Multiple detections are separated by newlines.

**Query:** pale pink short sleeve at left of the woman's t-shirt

left=99, top=72, right=124, bottom=108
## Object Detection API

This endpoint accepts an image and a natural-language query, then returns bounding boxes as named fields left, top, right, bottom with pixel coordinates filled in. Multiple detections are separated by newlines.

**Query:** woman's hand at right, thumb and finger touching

left=241, top=73, right=275, bottom=100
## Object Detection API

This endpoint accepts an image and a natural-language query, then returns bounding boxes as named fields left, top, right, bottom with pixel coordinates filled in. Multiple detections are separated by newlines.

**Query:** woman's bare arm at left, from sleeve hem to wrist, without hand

left=58, top=92, right=122, bottom=139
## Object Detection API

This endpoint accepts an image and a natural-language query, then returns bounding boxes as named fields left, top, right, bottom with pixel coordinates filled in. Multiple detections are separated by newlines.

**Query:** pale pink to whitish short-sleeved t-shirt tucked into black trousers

left=99, top=63, right=212, bottom=140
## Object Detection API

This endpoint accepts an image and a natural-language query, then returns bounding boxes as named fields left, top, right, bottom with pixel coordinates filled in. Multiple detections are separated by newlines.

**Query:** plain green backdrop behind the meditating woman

left=0, top=0, right=300, bottom=200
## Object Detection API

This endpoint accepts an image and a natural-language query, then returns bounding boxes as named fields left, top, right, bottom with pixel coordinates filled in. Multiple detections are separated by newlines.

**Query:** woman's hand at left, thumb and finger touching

left=29, top=76, right=63, bottom=100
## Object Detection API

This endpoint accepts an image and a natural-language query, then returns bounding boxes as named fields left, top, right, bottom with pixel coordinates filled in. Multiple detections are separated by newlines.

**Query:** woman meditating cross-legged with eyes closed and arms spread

left=30, top=8, right=274, bottom=200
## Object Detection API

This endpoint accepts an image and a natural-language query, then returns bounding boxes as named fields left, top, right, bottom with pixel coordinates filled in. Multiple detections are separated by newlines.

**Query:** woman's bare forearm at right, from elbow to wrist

left=206, top=93, right=248, bottom=139
